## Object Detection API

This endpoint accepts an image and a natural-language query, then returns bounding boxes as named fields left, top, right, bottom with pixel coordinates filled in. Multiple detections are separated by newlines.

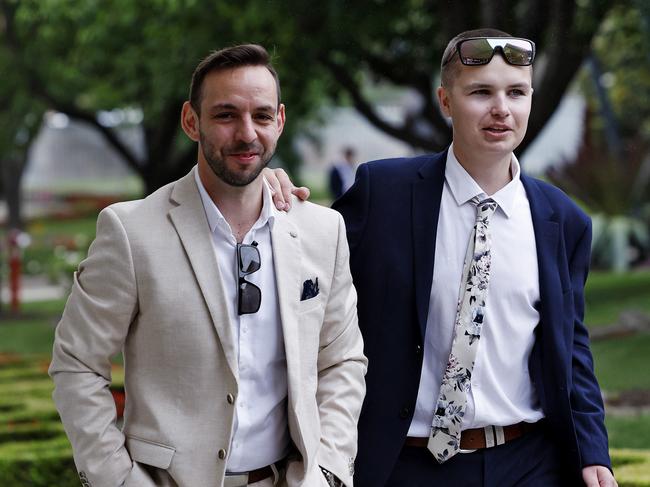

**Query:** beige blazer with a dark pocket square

left=50, top=171, right=366, bottom=487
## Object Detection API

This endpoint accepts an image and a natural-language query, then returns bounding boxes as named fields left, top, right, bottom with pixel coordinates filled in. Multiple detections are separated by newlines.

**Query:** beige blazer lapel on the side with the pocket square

left=271, top=211, right=302, bottom=411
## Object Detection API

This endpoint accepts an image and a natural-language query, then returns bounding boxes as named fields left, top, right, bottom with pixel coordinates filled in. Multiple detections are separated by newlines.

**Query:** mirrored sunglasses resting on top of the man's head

left=442, top=37, right=535, bottom=66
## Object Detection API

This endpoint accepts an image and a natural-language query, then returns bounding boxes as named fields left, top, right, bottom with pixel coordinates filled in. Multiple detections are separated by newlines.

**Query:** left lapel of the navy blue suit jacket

left=412, top=151, right=447, bottom=340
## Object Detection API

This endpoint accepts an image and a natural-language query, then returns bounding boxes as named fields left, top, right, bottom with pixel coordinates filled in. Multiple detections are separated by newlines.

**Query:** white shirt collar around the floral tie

left=445, top=143, right=521, bottom=218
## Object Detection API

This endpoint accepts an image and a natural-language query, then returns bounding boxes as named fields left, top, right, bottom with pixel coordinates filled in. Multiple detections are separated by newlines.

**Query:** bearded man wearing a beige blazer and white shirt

left=50, top=45, right=366, bottom=487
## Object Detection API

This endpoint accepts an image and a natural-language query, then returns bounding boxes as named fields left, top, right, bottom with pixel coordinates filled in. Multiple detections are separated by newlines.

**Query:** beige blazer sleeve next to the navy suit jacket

left=316, top=216, right=367, bottom=487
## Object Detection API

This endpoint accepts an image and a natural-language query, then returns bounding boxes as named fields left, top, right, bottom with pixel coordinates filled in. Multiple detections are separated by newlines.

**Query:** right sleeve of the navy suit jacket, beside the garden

left=569, top=220, right=611, bottom=470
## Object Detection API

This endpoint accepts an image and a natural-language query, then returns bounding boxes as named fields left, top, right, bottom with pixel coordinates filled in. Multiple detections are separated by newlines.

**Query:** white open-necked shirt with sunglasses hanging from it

left=194, top=171, right=290, bottom=472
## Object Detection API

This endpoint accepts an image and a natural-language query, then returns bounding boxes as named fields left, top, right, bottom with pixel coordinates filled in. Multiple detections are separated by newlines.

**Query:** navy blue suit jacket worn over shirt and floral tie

left=334, top=151, right=610, bottom=487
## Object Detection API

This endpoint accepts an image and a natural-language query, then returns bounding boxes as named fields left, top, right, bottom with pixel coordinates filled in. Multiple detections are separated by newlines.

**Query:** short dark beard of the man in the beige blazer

left=199, top=131, right=275, bottom=187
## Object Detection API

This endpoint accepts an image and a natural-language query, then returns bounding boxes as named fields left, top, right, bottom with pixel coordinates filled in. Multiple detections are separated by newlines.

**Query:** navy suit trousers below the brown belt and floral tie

left=386, top=430, right=567, bottom=487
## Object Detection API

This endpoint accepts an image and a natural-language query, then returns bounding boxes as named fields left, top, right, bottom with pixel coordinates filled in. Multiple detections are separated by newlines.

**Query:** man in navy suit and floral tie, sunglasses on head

left=274, top=29, right=616, bottom=487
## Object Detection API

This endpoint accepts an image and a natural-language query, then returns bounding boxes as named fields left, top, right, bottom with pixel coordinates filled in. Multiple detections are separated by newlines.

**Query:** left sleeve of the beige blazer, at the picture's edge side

left=49, top=208, right=137, bottom=487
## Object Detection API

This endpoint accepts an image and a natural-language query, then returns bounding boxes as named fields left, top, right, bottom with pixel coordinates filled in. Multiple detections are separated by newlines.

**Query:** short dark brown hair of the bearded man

left=190, top=44, right=280, bottom=114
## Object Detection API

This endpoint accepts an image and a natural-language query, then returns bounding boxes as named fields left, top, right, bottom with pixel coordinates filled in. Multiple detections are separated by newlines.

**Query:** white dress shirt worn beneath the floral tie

left=408, top=145, right=543, bottom=437
